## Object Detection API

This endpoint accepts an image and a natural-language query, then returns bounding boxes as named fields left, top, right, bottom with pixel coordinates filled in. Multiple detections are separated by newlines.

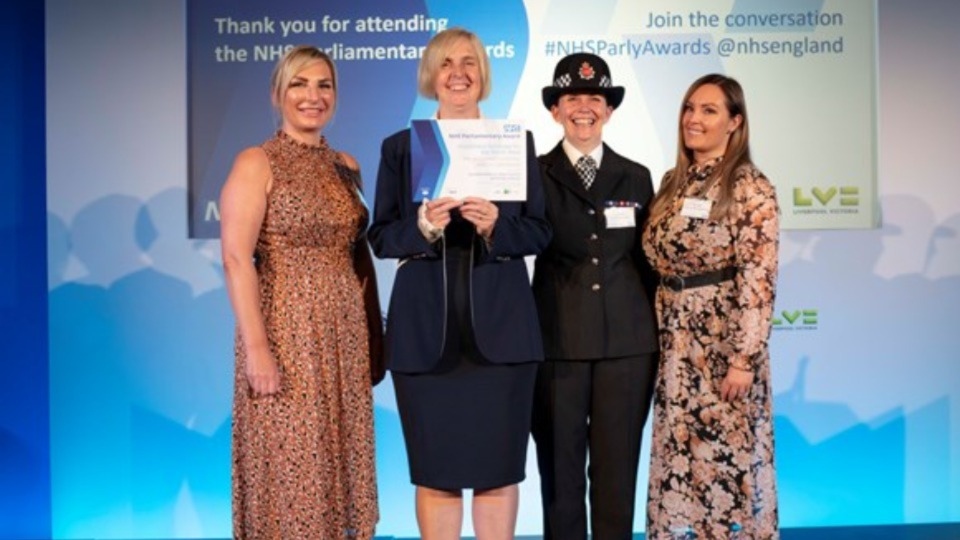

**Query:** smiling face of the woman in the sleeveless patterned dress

left=280, top=60, right=337, bottom=144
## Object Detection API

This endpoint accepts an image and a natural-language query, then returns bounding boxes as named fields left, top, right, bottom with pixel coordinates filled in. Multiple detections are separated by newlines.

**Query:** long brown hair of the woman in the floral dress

left=650, top=73, right=751, bottom=219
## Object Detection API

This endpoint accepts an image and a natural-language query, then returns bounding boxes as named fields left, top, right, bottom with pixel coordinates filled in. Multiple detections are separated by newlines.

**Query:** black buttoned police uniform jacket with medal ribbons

left=533, top=142, right=659, bottom=360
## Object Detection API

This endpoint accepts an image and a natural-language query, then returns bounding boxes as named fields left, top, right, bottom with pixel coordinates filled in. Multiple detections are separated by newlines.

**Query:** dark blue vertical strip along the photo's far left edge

left=0, top=2, right=50, bottom=538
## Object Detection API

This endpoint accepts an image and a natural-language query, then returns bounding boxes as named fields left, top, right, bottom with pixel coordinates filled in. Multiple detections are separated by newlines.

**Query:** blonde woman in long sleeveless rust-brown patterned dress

left=221, top=46, right=379, bottom=540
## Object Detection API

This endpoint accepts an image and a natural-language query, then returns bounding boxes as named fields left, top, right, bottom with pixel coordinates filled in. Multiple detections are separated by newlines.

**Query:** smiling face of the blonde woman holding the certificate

left=433, top=39, right=483, bottom=118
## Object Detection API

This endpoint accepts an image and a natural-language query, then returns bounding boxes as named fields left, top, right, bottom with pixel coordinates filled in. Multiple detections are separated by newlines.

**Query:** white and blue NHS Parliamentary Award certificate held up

left=410, top=119, right=527, bottom=202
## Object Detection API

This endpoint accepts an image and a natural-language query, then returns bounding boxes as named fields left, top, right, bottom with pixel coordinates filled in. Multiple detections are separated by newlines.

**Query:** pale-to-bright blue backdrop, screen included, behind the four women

left=30, top=0, right=960, bottom=539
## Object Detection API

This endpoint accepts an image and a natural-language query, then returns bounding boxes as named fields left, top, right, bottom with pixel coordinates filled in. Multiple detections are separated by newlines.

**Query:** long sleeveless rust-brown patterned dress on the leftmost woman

left=232, top=131, right=378, bottom=540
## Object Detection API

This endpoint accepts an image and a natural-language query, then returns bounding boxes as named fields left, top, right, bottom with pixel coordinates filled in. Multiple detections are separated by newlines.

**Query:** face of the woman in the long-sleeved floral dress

left=680, top=84, right=743, bottom=163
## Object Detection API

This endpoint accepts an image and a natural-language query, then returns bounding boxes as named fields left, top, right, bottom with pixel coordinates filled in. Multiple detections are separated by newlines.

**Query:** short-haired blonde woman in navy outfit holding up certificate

left=369, top=28, right=550, bottom=539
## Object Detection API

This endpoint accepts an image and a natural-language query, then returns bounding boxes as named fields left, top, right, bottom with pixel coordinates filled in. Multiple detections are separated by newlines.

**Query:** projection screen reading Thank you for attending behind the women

left=187, top=0, right=877, bottom=238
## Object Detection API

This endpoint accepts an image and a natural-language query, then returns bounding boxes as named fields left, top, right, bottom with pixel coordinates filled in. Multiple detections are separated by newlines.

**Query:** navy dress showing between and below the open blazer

left=391, top=217, right=538, bottom=490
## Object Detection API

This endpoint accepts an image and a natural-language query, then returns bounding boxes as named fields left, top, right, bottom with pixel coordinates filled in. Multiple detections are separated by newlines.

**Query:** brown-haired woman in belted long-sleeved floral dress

left=643, top=74, right=779, bottom=540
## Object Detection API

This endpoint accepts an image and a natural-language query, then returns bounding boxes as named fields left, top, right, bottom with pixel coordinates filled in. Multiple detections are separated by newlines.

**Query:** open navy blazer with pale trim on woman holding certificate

left=368, top=129, right=551, bottom=373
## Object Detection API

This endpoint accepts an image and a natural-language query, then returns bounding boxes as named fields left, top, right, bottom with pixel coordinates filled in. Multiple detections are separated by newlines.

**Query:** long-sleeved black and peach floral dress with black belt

left=643, top=165, right=779, bottom=540
